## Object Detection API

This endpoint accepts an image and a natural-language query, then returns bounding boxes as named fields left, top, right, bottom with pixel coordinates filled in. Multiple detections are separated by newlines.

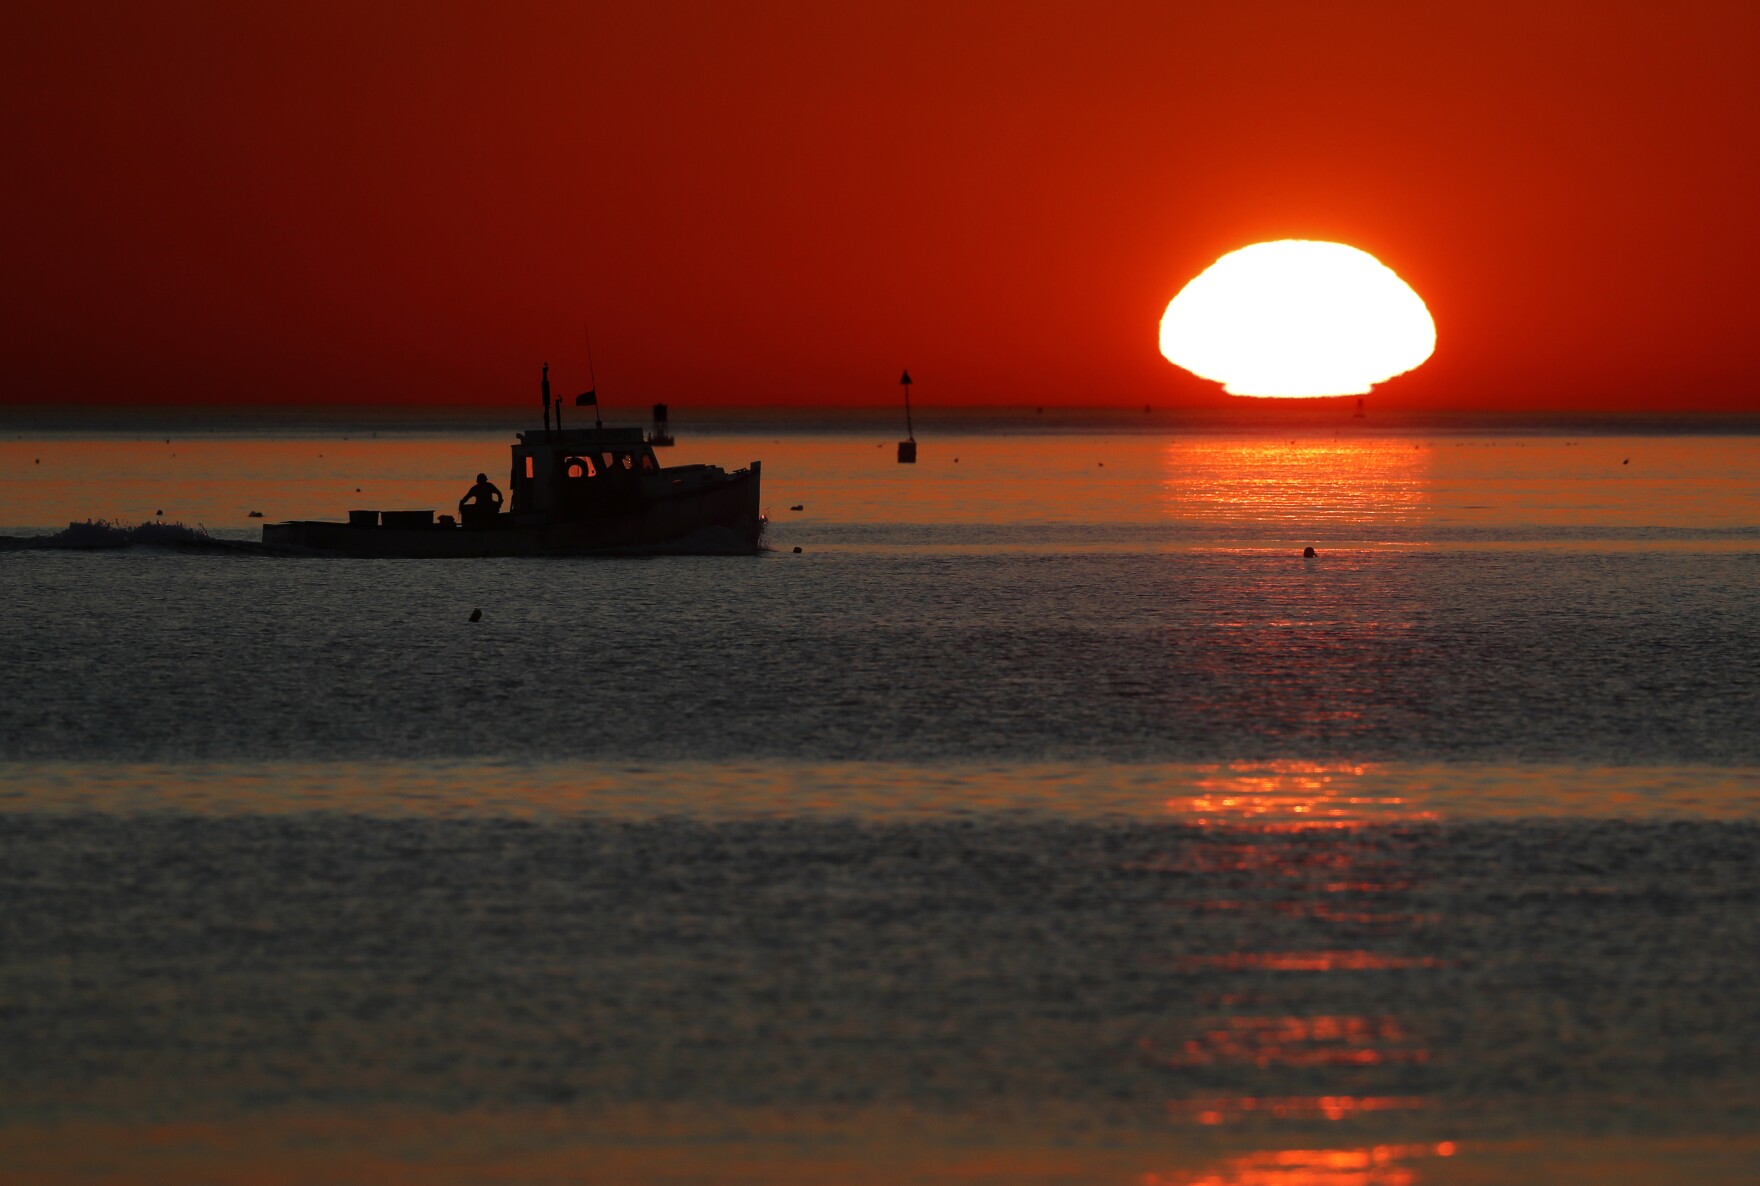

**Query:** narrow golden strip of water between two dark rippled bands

left=0, top=760, right=1760, bottom=812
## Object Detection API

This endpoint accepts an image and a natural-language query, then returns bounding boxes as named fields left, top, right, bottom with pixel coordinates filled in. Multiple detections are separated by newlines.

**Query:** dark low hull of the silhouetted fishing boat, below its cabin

left=262, top=468, right=764, bottom=560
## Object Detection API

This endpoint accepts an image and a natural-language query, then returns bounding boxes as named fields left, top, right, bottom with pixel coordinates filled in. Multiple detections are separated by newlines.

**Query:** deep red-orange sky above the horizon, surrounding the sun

left=0, top=0, right=1760, bottom=410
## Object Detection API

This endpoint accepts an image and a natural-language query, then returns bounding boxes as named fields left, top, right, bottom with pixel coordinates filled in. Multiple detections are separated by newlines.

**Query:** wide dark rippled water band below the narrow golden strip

left=0, top=813, right=1760, bottom=1137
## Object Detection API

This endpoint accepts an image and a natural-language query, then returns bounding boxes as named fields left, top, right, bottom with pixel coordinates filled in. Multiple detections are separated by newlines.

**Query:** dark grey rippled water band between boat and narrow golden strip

left=0, top=551, right=1760, bottom=765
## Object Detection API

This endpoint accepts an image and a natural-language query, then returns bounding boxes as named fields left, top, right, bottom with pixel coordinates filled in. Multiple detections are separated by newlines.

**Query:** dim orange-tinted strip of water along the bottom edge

left=0, top=1098, right=1760, bottom=1186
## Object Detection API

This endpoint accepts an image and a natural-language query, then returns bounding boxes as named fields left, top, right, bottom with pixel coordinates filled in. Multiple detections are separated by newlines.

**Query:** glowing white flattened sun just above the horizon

left=1162, top=239, right=1436, bottom=396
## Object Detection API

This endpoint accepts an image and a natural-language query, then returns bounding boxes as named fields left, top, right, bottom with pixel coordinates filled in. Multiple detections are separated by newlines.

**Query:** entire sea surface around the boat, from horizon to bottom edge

left=0, top=417, right=1760, bottom=1186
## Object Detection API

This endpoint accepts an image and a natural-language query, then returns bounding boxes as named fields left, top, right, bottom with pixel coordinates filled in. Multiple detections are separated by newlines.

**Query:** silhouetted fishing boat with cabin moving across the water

left=262, top=406, right=764, bottom=558
